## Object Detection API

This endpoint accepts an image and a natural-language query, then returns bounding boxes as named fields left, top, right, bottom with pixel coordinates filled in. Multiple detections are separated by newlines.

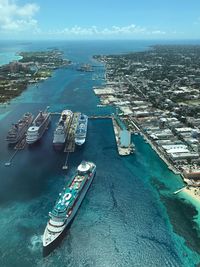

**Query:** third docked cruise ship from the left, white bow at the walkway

left=53, top=110, right=73, bottom=150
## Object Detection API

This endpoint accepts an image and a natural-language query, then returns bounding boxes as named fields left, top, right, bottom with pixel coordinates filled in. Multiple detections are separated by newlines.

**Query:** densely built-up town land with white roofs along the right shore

left=94, top=45, right=200, bottom=201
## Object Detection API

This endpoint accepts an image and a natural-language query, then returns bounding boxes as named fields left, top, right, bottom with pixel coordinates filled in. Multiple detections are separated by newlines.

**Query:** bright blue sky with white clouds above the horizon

left=0, top=0, right=200, bottom=40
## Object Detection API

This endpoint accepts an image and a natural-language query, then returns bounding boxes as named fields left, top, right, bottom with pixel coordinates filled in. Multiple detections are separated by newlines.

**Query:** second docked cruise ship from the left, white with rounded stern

left=26, top=111, right=51, bottom=144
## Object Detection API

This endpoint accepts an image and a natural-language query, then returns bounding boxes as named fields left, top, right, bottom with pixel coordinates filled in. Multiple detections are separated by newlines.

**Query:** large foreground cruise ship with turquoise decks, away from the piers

left=43, top=161, right=96, bottom=252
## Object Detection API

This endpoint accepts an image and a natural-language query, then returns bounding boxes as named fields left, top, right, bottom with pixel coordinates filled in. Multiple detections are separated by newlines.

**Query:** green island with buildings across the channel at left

left=0, top=49, right=71, bottom=103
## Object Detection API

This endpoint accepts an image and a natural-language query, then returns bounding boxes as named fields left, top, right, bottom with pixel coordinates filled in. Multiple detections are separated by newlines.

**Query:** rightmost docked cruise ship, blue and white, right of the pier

left=75, top=114, right=88, bottom=146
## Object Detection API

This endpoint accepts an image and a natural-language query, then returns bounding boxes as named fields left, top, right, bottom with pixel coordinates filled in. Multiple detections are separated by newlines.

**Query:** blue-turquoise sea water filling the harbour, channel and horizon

left=0, top=41, right=200, bottom=267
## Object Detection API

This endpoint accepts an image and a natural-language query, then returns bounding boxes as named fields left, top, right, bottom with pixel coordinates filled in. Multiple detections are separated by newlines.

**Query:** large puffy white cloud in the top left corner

left=0, top=0, right=39, bottom=33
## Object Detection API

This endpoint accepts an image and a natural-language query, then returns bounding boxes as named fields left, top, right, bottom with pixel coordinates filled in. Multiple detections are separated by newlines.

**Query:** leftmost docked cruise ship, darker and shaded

left=6, top=112, right=33, bottom=144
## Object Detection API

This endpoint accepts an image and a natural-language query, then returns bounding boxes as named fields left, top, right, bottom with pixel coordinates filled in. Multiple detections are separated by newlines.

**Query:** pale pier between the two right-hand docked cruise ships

left=64, top=112, right=80, bottom=152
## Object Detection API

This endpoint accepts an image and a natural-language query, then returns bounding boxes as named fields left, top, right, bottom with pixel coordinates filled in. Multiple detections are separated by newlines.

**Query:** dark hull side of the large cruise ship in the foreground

left=43, top=170, right=96, bottom=256
